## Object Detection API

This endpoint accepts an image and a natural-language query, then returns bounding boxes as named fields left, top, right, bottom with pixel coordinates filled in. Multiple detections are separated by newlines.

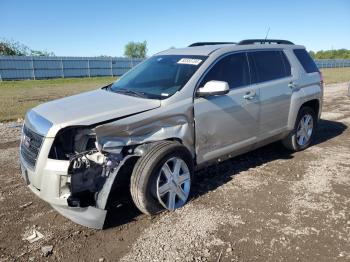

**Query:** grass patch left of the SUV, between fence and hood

left=0, top=77, right=116, bottom=122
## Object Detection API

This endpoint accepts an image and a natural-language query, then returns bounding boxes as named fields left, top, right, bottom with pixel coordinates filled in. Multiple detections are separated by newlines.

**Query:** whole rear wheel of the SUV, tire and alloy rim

left=282, top=107, right=316, bottom=151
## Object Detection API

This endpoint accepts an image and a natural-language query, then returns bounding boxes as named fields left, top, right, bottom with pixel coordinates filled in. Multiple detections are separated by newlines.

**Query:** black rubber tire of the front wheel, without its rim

left=130, top=141, right=193, bottom=215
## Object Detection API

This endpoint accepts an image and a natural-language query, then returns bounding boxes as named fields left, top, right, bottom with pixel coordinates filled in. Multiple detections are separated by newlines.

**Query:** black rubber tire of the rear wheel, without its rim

left=282, top=106, right=317, bottom=152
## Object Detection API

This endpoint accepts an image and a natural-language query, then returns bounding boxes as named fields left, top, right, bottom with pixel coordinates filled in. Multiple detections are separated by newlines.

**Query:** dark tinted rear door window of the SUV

left=248, top=51, right=291, bottom=83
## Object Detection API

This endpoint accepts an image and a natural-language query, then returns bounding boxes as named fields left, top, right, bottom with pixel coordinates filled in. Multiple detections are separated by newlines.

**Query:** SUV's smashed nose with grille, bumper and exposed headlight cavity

left=20, top=112, right=127, bottom=228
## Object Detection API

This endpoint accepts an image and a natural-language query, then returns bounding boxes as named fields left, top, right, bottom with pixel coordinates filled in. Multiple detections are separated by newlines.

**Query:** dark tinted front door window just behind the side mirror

left=200, top=53, right=250, bottom=89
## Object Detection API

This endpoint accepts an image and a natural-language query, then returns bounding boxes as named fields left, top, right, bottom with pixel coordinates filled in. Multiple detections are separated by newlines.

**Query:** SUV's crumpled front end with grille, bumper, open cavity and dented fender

left=20, top=89, right=193, bottom=228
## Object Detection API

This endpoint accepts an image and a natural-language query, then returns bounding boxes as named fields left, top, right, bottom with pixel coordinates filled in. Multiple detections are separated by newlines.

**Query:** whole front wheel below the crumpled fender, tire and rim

left=130, top=141, right=193, bottom=215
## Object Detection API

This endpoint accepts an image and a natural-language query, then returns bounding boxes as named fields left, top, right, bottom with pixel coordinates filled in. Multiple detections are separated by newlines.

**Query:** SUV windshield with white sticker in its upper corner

left=110, top=55, right=206, bottom=99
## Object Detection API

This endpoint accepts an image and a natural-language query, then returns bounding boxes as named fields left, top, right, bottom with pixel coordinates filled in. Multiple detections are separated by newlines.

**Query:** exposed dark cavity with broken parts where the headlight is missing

left=49, top=127, right=127, bottom=207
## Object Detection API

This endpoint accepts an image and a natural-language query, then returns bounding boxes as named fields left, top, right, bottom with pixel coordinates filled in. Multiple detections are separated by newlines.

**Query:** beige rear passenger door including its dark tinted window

left=248, top=50, right=295, bottom=140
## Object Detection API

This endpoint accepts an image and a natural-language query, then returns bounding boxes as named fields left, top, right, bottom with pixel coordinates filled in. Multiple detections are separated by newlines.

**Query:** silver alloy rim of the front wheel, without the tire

left=157, top=157, right=191, bottom=210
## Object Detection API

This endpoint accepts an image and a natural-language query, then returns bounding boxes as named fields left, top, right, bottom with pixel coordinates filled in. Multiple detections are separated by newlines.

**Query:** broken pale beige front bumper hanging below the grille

left=20, top=158, right=107, bottom=229
